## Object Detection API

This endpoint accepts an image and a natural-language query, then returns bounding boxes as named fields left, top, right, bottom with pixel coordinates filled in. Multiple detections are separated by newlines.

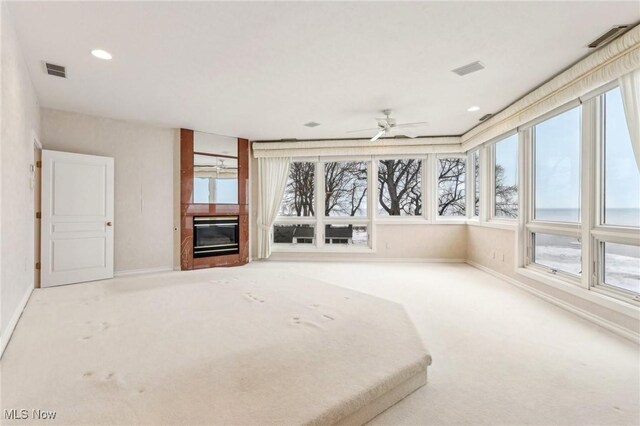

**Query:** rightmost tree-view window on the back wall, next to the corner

left=438, top=157, right=466, bottom=216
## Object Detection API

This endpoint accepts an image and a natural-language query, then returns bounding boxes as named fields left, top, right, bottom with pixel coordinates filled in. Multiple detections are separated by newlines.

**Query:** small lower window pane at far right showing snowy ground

left=602, top=242, right=640, bottom=294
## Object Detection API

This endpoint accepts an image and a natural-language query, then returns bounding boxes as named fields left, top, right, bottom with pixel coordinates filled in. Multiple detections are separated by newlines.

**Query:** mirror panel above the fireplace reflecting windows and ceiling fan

left=193, top=132, right=238, bottom=204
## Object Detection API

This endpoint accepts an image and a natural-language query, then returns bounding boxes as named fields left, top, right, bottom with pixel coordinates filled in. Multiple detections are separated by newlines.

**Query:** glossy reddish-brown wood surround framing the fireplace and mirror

left=180, top=129, right=249, bottom=271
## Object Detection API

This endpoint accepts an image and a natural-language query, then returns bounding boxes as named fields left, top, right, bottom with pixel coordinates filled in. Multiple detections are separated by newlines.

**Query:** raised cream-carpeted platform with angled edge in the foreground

left=2, top=266, right=430, bottom=425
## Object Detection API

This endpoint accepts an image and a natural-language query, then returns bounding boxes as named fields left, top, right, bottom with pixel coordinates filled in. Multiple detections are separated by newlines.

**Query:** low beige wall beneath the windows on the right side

left=467, top=225, right=639, bottom=333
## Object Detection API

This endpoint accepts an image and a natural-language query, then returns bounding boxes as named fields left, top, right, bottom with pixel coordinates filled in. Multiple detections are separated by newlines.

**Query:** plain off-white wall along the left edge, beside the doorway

left=0, top=2, right=40, bottom=346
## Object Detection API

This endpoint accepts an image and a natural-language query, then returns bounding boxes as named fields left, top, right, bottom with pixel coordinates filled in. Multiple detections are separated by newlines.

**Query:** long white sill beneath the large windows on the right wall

left=516, top=267, right=640, bottom=318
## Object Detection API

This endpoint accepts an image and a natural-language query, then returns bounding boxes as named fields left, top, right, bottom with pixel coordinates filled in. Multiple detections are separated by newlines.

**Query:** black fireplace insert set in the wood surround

left=193, top=216, right=240, bottom=258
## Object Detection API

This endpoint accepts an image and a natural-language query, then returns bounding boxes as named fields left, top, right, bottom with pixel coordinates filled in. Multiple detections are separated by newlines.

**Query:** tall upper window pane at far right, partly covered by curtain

left=603, top=88, right=640, bottom=227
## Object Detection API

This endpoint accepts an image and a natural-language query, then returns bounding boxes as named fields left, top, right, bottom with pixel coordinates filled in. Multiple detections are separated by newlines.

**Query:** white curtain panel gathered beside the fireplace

left=258, top=157, right=291, bottom=259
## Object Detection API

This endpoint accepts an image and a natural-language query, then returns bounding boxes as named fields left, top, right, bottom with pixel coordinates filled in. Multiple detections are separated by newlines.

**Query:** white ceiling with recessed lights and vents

left=9, top=1, right=640, bottom=140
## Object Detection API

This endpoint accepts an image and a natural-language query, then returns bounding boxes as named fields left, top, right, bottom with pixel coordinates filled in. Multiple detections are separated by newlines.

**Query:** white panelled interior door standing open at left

left=40, top=150, right=114, bottom=287
